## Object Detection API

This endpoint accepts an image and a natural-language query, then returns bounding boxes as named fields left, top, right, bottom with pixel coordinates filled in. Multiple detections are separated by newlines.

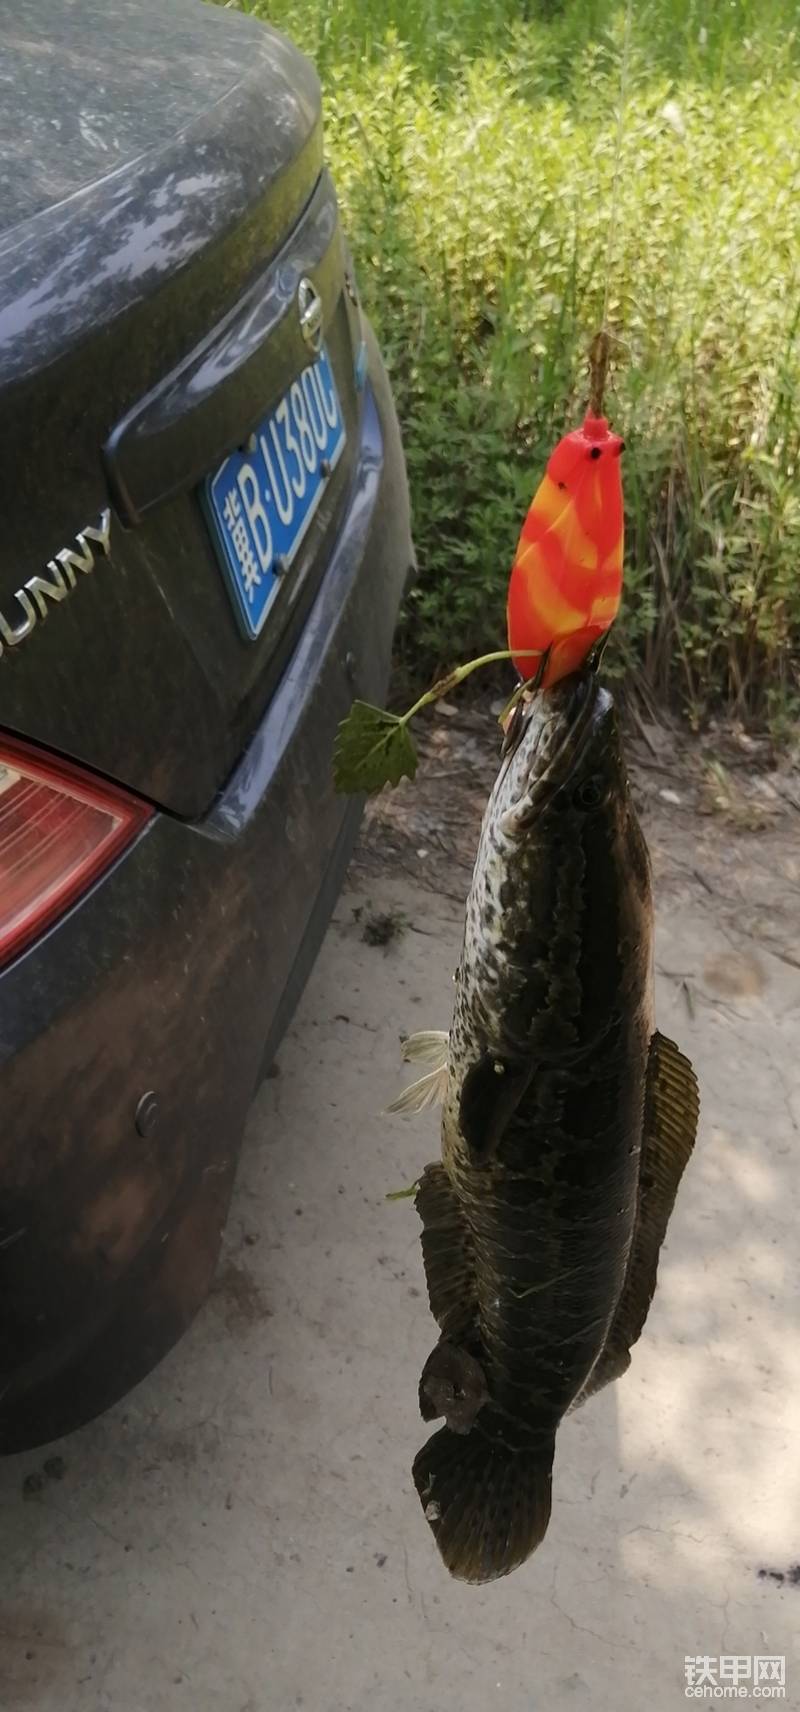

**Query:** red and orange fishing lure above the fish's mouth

left=507, top=411, right=624, bottom=685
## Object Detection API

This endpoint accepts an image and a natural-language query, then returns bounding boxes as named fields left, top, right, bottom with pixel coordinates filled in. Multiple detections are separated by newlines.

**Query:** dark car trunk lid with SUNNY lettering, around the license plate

left=0, top=0, right=358, bottom=817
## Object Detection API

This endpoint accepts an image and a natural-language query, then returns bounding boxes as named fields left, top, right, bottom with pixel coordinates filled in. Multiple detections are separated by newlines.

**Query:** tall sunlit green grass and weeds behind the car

left=234, top=0, right=800, bottom=726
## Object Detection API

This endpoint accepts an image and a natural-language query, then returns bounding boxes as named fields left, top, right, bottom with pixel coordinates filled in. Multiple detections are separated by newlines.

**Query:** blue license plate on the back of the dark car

left=204, top=349, right=344, bottom=640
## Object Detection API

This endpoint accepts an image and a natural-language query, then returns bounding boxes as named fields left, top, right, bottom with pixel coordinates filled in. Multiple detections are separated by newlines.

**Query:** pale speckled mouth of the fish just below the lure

left=502, top=668, right=612, bottom=834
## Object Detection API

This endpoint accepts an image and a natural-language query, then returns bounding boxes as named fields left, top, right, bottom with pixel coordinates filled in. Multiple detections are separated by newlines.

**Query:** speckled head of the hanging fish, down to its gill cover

left=479, top=666, right=653, bottom=1061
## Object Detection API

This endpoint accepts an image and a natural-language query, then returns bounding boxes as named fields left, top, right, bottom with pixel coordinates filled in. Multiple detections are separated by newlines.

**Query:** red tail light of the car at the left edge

left=0, top=738, right=151, bottom=966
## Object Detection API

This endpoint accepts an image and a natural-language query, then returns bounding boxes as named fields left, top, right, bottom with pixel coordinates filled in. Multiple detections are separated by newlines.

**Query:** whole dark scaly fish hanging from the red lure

left=396, top=664, right=699, bottom=1582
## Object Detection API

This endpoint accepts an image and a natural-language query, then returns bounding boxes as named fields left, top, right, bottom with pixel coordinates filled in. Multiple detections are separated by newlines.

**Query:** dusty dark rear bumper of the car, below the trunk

left=0, top=344, right=411, bottom=1452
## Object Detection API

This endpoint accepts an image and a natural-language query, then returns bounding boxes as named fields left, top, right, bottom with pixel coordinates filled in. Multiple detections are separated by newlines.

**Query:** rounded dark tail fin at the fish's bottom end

left=413, top=1407, right=555, bottom=1582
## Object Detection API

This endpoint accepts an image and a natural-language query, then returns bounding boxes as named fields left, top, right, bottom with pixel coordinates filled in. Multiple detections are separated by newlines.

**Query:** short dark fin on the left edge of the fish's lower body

left=415, top=1162, right=478, bottom=1337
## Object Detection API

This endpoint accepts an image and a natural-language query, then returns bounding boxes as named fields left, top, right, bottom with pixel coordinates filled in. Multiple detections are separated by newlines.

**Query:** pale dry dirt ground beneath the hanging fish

left=0, top=710, right=800, bottom=1712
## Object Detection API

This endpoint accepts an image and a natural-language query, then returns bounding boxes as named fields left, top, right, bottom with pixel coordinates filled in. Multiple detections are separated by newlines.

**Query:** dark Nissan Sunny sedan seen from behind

left=0, top=0, right=413, bottom=1452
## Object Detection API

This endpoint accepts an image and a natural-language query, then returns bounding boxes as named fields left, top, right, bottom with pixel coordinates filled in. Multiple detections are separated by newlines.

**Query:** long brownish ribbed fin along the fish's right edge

left=577, top=1034, right=701, bottom=1402
